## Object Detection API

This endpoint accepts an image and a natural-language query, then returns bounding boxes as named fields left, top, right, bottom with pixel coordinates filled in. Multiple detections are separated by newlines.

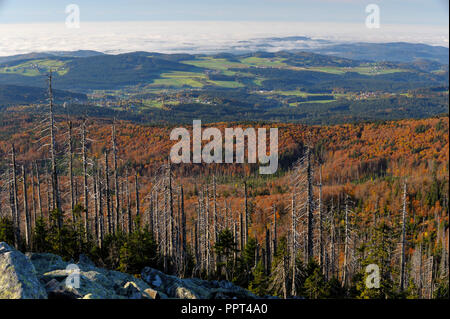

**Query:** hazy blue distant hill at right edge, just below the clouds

left=309, top=42, right=449, bottom=64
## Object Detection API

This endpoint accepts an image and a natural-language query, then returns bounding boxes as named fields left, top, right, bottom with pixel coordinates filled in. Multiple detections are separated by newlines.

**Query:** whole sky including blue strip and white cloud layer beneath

left=0, top=0, right=449, bottom=55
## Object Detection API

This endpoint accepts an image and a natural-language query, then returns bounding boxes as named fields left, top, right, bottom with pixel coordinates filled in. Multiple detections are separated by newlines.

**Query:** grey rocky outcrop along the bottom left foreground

left=0, top=243, right=256, bottom=299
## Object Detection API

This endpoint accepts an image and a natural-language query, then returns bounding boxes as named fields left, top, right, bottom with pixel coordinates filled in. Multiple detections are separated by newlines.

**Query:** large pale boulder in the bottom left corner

left=0, top=242, right=47, bottom=299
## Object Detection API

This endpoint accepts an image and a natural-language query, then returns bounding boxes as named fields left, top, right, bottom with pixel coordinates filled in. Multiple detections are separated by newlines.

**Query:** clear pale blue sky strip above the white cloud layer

left=0, top=0, right=448, bottom=26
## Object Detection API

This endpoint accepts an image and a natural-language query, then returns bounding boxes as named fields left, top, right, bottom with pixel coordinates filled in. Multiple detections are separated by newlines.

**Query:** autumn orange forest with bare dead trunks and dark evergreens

left=0, top=75, right=449, bottom=299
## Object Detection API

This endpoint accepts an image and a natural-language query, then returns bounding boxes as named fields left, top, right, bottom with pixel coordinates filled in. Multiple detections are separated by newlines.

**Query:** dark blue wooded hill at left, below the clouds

left=0, top=52, right=203, bottom=90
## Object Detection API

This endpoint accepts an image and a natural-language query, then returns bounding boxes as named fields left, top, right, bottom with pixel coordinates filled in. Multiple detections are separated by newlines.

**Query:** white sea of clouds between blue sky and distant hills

left=0, top=21, right=449, bottom=56
